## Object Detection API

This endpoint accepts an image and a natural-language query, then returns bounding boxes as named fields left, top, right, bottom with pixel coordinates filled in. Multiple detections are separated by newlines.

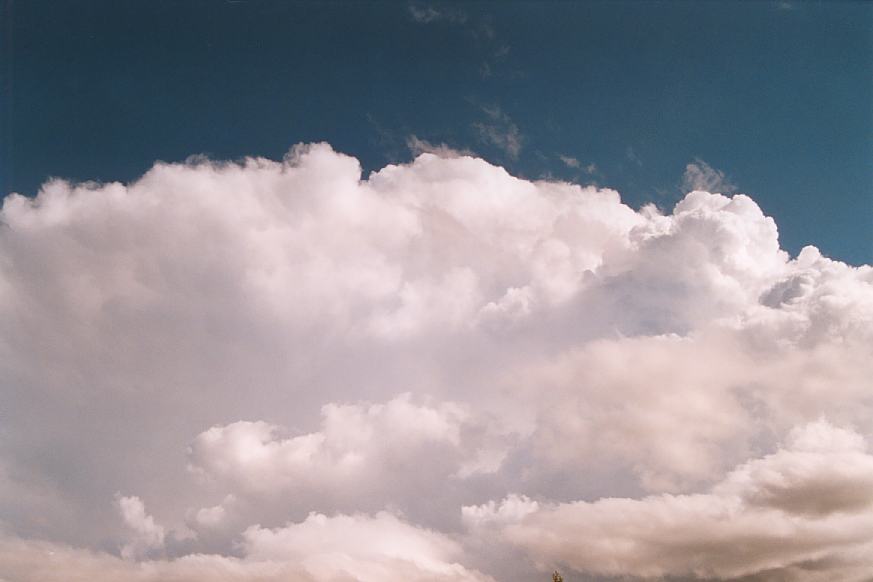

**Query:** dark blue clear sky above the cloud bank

left=0, top=0, right=873, bottom=263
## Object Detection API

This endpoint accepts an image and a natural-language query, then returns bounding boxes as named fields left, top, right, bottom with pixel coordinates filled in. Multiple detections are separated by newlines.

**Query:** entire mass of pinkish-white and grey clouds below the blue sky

left=0, top=142, right=873, bottom=582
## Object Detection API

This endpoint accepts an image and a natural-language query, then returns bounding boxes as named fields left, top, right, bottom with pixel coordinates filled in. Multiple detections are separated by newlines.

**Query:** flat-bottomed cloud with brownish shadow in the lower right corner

left=498, top=422, right=873, bottom=580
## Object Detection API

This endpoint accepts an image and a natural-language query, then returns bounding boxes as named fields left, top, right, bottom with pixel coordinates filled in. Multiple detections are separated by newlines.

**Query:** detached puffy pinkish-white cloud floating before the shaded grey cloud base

left=189, top=393, right=503, bottom=502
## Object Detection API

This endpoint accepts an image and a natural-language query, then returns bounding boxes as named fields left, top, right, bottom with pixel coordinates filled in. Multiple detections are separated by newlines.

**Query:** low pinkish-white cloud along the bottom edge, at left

left=0, top=512, right=493, bottom=582
